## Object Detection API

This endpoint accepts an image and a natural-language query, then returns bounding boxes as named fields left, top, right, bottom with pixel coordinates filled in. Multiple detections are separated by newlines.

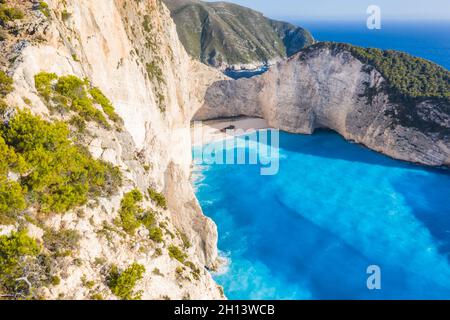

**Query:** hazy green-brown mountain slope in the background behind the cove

left=164, top=0, right=314, bottom=69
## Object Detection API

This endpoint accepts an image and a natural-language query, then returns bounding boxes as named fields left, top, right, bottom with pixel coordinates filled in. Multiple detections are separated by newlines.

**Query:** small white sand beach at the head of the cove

left=191, top=117, right=269, bottom=146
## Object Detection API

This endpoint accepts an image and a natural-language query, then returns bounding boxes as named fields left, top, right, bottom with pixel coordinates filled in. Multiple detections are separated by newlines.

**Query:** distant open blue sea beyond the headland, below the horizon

left=290, top=20, right=450, bottom=69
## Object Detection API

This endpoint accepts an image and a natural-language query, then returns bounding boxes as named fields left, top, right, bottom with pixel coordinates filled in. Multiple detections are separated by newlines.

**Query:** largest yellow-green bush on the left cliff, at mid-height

left=0, top=111, right=120, bottom=212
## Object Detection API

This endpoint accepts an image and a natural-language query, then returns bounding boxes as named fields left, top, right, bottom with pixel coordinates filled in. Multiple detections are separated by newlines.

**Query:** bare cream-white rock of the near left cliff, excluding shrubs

left=0, top=0, right=224, bottom=299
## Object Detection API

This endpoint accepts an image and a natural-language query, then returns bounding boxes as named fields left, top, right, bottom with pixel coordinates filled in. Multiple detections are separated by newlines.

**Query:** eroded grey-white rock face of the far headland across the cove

left=200, top=47, right=450, bottom=166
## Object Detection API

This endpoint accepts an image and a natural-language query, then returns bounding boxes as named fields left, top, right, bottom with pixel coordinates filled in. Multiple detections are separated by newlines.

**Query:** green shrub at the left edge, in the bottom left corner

left=0, top=230, right=40, bottom=298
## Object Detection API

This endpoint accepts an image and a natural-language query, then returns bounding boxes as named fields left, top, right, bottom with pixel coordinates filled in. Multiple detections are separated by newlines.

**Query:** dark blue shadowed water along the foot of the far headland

left=274, top=130, right=450, bottom=261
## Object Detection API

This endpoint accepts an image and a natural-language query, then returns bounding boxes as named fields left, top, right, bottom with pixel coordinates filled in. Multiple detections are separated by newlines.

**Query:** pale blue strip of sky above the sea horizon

left=210, top=0, right=450, bottom=20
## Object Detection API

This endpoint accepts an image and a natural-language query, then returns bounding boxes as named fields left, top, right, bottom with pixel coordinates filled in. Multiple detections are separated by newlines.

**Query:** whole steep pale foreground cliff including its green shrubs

left=0, top=0, right=224, bottom=299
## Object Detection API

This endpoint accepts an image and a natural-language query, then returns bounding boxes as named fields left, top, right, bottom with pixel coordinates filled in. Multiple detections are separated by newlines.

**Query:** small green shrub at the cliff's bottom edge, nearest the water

left=107, top=263, right=145, bottom=300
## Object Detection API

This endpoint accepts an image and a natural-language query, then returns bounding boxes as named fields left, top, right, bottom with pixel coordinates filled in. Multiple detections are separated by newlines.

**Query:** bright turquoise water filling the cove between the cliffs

left=194, top=131, right=450, bottom=299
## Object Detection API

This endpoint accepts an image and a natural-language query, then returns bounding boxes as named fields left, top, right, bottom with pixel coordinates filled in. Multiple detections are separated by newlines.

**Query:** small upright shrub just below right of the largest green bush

left=119, top=189, right=143, bottom=235
